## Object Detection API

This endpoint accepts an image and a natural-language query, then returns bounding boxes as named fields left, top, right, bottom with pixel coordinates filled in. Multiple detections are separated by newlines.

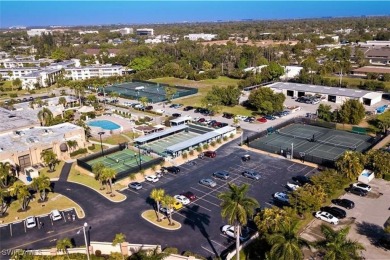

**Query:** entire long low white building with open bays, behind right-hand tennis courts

left=267, top=82, right=382, bottom=106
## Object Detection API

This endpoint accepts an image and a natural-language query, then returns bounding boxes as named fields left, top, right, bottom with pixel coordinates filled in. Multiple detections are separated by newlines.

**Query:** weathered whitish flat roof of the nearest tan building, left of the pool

left=0, top=123, right=81, bottom=153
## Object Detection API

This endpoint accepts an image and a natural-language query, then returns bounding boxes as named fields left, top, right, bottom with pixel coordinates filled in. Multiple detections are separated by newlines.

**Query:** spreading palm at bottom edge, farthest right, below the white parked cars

left=315, top=225, right=364, bottom=260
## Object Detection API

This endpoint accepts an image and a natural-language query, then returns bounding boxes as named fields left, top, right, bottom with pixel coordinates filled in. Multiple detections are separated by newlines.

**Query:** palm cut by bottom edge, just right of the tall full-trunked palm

left=267, top=221, right=307, bottom=260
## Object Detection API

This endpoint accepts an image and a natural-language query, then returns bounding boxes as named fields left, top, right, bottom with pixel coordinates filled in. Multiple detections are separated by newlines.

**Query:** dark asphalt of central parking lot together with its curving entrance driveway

left=0, top=141, right=314, bottom=258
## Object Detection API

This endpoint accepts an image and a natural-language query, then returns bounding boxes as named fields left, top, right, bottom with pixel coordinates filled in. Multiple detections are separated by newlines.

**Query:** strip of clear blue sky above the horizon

left=0, top=0, right=390, bottom=28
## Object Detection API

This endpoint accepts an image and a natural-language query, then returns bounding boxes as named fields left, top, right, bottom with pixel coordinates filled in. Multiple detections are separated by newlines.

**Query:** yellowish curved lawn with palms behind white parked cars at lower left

left=0, top=192, right=84, bottom=223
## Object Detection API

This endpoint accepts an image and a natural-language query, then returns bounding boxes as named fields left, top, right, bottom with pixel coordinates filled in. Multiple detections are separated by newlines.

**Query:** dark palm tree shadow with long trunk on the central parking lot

left=180, top=205, right=219, bottom=257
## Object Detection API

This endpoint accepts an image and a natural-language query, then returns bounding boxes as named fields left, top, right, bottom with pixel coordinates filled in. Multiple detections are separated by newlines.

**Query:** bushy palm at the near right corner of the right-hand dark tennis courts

left=336, top=151, right=364, bottom=180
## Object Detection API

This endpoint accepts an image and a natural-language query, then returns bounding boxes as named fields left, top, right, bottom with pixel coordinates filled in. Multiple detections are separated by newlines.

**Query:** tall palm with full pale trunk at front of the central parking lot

left=218, top=183, right=259, bottom=260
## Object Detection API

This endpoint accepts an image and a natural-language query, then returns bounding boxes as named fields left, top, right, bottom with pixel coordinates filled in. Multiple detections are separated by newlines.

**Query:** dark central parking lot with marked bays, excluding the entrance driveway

left=119, top=142, right=314, bottom=257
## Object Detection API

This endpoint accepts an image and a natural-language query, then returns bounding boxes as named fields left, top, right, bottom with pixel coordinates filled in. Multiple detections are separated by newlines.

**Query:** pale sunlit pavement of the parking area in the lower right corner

left=301, top=179, right=390, bottom=259
